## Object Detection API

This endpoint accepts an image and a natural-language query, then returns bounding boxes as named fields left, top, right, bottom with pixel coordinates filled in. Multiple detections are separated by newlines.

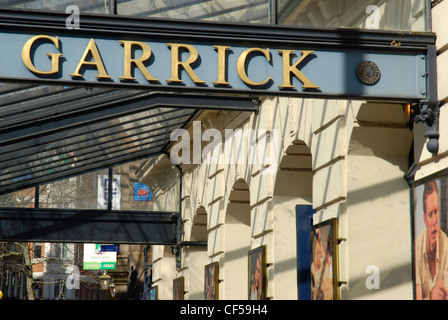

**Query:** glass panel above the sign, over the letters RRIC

left=117, top=0, right=271, bottom=23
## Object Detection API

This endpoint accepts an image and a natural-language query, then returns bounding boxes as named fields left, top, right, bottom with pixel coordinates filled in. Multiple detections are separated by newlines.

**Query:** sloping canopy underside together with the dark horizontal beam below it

left=0, top=84, right=258, bottom=245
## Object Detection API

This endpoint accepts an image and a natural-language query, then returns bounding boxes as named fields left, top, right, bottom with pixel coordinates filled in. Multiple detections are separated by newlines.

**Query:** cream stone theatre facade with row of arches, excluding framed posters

left=136, top=1, right=448, bottom=300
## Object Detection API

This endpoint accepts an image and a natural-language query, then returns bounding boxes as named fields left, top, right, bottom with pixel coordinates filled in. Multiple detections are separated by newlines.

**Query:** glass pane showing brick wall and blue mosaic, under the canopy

left=113, top=160, right=153, bottom=211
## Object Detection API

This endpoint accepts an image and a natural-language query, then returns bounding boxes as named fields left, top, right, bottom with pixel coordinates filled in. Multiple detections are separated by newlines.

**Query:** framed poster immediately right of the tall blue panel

left=310, top=219, right=338, bottom=300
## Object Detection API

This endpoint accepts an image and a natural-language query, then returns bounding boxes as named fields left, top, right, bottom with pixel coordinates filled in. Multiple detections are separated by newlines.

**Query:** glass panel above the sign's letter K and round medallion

left=277, top=0, right=430, bottom=31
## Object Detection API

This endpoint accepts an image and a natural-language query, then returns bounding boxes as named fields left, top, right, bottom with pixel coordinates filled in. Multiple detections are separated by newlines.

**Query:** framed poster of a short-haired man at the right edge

left=413, top=174, right=448, bottom=300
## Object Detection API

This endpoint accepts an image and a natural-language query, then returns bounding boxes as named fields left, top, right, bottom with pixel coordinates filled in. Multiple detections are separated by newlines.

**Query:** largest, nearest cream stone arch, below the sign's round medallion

left=341, top=103, right=413, bottom=299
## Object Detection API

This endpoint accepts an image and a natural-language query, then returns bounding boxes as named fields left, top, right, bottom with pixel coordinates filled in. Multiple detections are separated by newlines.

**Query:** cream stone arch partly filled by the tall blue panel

left=272, top=139, right=313, bottom=300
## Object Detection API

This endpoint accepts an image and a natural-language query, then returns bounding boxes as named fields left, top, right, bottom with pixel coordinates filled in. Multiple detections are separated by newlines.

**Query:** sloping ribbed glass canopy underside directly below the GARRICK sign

left=0, top=84, right=258, bottom=194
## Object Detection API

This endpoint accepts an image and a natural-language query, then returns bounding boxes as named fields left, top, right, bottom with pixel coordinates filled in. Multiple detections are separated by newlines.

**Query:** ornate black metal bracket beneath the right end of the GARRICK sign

left=411, top=100, right=440, bottom=154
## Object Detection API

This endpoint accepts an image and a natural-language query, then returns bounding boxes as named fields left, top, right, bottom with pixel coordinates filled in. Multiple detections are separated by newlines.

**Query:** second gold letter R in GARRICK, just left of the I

left=166, top=43, right=205, bottom=83
